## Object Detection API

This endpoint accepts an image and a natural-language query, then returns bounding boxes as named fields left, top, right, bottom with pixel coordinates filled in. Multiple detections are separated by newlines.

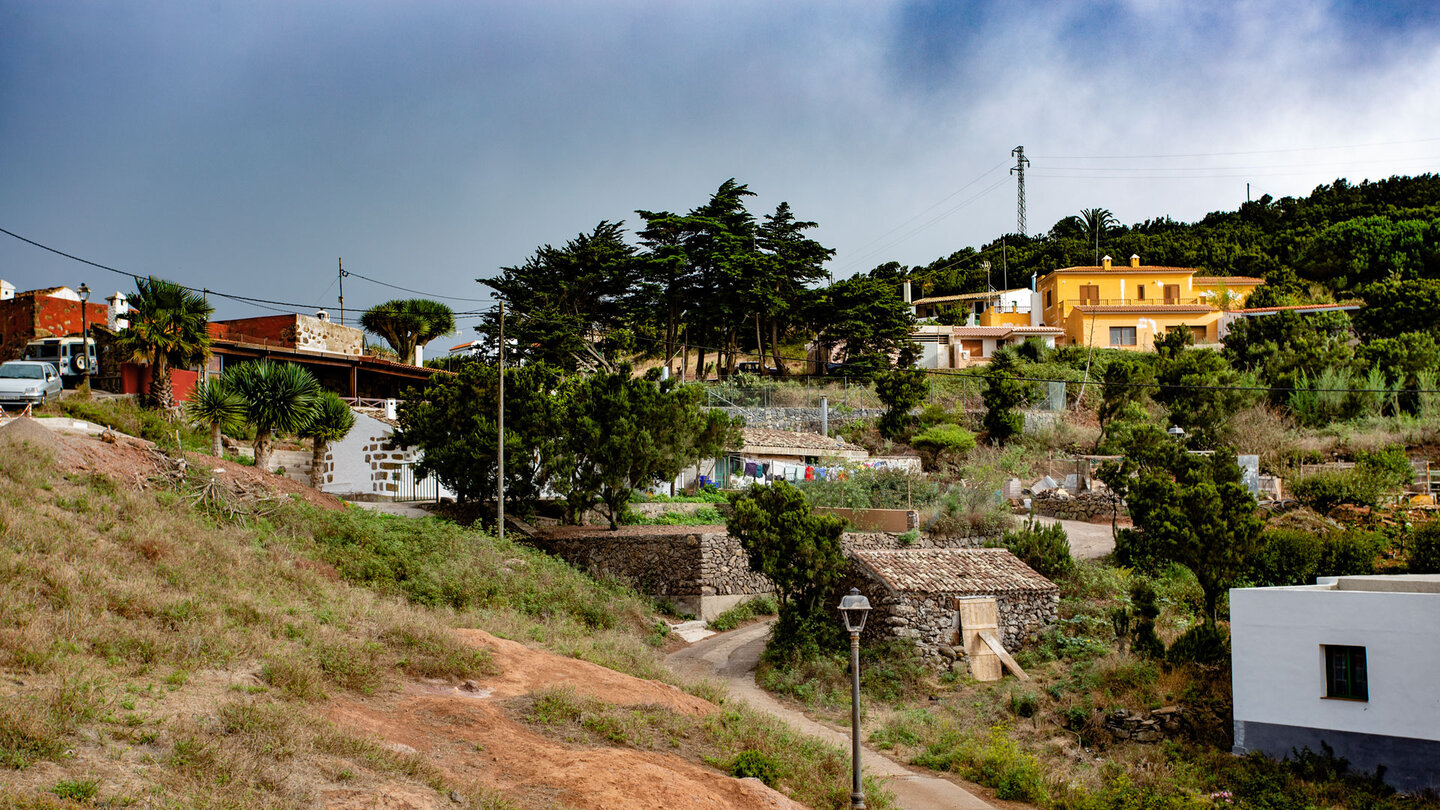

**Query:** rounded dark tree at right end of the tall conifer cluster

left=811, top=275, right=914, bottom=373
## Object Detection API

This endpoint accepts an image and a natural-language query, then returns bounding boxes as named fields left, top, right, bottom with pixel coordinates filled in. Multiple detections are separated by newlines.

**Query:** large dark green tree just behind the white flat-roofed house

left=1099, top=427, right=1264, bottom=621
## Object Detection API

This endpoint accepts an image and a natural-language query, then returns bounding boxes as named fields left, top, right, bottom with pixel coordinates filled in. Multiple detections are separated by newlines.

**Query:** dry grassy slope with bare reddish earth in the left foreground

left=0, top=419, right=864, bottom=810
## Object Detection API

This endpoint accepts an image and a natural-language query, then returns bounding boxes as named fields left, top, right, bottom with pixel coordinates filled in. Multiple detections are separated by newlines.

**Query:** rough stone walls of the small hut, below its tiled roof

left=865, top=587, right=1060, bottom=670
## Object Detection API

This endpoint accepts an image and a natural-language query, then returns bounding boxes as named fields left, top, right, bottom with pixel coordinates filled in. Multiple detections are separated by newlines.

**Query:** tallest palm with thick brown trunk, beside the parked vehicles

left=117, top=275, right=215, bottom=408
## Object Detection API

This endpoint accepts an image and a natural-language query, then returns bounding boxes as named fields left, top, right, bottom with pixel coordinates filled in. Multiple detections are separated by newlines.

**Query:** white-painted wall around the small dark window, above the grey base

left=1230, top=576, right=1440, bottom=745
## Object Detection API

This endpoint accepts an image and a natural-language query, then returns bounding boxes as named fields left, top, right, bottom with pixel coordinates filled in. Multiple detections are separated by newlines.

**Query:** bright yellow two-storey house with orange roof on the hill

left=1035, top=255, right=1264, bottom=350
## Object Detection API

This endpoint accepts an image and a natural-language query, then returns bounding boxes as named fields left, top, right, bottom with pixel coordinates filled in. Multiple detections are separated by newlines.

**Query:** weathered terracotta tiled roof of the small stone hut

left=854, top=549, right=1058, bottom=595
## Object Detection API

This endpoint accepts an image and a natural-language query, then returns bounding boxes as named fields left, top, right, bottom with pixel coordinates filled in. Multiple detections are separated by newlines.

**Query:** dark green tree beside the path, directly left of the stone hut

left=726, top=481, right=845, bottom=660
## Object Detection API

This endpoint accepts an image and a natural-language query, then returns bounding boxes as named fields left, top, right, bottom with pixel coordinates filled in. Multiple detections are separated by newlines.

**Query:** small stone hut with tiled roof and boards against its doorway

left=854, top=549, right=1060, bottom=669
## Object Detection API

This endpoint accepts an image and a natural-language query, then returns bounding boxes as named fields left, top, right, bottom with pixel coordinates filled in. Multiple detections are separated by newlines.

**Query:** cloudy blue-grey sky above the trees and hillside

left=0, top=0, right=1440, bottom=337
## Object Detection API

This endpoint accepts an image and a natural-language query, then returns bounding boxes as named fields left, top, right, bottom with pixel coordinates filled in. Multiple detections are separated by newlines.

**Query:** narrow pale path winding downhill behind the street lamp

left=665, top=624, right=995, bottom=810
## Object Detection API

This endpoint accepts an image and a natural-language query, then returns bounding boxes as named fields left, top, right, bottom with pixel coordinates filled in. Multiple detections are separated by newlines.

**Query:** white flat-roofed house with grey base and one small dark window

left=1230, top=574, right=1440, bottom=791
